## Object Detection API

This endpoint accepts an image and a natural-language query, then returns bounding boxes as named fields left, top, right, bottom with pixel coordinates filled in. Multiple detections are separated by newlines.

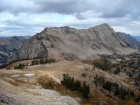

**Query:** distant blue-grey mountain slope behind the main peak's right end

left=116, top=32, right=140, bottom=49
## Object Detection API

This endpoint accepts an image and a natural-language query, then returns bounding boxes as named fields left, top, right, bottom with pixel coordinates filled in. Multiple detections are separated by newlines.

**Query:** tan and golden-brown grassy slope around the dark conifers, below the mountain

left=0, top=60, right=140, bottom=105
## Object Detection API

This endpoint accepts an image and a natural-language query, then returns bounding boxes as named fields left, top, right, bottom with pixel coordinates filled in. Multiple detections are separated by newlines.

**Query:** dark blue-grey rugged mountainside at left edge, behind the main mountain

left=0, top=36, right=25, bottom=64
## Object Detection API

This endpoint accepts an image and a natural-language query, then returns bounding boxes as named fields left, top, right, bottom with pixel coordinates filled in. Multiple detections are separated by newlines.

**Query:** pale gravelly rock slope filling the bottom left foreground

left=0, top=75, right=78, bottom=105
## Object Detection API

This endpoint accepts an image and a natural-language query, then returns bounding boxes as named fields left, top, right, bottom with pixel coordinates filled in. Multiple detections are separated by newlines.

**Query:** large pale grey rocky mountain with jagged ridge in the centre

left=13, top=24, right=134, bottom=60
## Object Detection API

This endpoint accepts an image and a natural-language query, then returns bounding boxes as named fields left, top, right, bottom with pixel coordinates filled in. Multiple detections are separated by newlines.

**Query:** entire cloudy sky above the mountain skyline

left=0, top=0, right=140, bottom=36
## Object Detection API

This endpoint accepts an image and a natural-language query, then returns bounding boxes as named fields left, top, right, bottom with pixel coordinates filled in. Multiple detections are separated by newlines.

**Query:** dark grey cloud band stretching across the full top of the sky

left=0, top=0, right=140, bottom=19
